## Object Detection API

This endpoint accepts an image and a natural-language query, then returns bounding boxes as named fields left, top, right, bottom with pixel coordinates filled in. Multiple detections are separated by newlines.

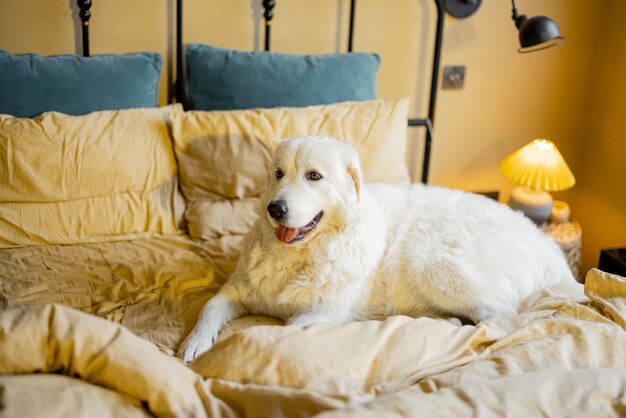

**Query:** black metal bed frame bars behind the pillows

left=77, top=0, right=444, bottom=183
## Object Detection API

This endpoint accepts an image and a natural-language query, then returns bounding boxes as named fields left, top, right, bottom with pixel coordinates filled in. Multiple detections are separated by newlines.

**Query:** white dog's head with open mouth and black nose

left=263, top=136, right=361, bottom=245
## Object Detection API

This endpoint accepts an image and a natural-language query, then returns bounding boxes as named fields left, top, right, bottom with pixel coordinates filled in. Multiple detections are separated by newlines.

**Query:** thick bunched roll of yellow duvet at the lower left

left=0, top=304, right=206, bottom=417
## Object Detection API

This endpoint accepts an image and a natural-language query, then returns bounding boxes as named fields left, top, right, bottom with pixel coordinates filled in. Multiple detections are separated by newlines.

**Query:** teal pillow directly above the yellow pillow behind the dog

left=185, top=44, right=380, bottom=110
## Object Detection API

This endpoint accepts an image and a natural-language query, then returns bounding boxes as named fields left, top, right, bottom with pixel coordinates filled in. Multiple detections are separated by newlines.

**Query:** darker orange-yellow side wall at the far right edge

left=572, top=0, right=626, bottom=268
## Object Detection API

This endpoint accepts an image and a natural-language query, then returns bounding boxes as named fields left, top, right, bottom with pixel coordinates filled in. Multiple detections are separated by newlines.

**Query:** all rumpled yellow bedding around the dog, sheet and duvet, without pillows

left=0, top=238, right=626, bottom=417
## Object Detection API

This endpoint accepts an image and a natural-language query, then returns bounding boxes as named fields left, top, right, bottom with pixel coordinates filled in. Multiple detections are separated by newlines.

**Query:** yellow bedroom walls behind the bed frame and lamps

left=0, top=0, right=626, bottom=274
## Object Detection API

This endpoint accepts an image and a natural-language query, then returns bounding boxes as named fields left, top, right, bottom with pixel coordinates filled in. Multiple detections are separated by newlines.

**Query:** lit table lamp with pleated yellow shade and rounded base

left=500, top=139, right=576, bottom=225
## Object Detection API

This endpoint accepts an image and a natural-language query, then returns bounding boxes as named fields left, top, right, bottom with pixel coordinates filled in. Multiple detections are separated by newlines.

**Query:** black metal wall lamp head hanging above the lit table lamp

left=511, top=0, right=565, bottom=53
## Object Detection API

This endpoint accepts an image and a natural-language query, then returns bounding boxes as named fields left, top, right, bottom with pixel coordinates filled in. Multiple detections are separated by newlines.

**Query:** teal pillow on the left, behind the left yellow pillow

left=0, top=50, right=163, bottom=117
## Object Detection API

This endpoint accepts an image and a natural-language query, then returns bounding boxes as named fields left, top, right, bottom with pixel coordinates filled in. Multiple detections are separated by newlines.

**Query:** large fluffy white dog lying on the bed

left=179, top=137, right=574, bottom=362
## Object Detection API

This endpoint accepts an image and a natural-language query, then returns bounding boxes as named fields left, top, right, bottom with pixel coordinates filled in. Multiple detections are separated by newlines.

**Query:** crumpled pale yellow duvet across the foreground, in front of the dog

left=0, top=270, right=626, bottom=417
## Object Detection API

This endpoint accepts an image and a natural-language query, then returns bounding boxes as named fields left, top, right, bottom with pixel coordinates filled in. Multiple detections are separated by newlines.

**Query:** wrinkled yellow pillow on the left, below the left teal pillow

left=0, top=107, right=183, bottom=248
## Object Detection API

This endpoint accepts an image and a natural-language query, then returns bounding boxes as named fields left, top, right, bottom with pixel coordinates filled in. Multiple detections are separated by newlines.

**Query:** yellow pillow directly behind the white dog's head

left=171, top=99, right=410, bottom=240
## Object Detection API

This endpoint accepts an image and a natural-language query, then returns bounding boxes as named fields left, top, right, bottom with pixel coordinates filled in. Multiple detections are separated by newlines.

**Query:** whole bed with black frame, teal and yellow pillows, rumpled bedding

left=0, top=0, right=626, bottom=417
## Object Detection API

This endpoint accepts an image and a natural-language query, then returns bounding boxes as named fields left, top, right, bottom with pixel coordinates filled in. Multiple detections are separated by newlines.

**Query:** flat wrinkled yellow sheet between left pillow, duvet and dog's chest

left=0, top=236, right=219, bottom=353
